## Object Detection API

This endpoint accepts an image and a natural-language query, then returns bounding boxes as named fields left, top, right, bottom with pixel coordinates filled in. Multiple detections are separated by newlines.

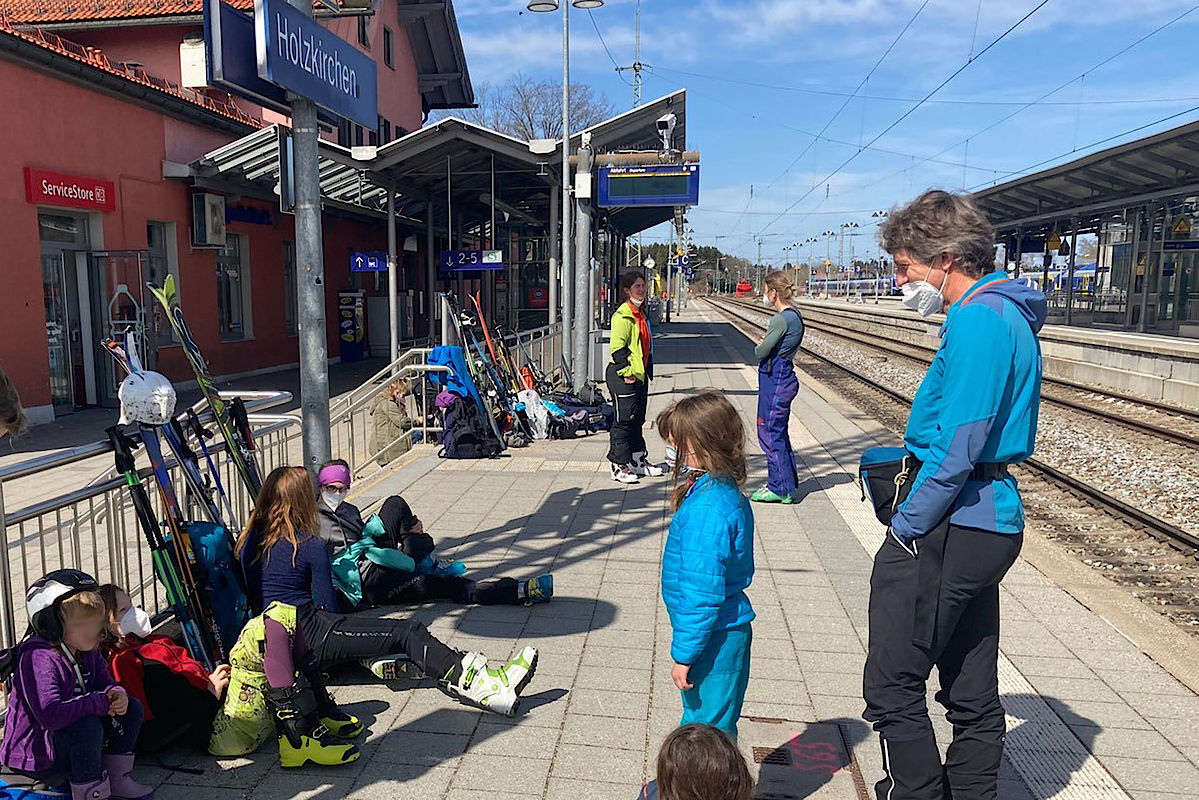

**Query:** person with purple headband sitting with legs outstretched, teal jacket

left=317, top=458, right=554, bottom=608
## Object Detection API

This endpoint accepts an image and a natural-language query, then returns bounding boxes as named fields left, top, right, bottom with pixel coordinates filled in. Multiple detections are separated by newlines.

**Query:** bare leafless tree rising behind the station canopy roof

left=435, top=73, right=614, bottom=140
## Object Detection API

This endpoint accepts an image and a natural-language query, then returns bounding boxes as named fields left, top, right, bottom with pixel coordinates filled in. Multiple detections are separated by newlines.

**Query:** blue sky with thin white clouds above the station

left=454, top=0, right=1199, bottom=265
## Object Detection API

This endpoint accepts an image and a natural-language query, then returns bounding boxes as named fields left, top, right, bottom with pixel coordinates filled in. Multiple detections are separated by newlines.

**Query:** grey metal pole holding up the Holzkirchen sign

left=288, top=0, right=332, bottom=477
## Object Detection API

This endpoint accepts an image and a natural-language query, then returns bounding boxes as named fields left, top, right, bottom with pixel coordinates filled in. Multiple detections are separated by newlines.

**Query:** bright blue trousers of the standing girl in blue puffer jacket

left=679, top=622, right=753, bottom=739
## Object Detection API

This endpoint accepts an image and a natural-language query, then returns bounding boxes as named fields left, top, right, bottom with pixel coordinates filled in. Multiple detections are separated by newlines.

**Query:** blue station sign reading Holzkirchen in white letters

left=254, top=0, right=379, bottom=131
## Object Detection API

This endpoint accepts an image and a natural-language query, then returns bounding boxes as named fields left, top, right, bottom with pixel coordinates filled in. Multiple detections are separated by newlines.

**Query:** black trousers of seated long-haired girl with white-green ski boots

left=297, top=603, right=464, bottom=680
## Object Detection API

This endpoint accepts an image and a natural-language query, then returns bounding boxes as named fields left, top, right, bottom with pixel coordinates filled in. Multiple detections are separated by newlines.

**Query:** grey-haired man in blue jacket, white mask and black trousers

left=863, top=191, right=1046, bottom=800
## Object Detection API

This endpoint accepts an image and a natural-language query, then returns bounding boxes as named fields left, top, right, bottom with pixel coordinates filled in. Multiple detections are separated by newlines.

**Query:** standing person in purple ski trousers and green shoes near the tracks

left=749, top=270, right=803, bottom=504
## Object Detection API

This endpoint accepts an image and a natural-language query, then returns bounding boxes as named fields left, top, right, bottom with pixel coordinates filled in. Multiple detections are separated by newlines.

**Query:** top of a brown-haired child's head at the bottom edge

left=638, top=724, right=753, bottom=800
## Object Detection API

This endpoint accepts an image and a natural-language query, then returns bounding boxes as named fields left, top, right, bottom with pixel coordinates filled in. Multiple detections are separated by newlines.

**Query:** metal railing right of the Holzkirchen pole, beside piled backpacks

left=330, top=323, right=562, bottom=481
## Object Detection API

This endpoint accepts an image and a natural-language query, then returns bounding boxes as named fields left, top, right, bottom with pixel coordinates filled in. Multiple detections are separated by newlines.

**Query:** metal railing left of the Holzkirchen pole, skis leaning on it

left=0, top=391, right=300, bottom=648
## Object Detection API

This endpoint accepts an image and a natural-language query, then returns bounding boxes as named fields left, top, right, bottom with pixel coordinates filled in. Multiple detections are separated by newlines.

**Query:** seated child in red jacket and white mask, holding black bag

left=97, top=583, right=229, bottom=753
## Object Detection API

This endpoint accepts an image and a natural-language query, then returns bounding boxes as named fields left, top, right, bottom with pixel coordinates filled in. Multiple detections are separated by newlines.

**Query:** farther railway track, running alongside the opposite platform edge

left=730, top=300, right=1199, bottom=447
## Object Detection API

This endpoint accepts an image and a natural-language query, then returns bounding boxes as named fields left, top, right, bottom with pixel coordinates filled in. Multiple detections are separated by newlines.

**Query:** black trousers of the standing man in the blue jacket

left=863, top=523, right=1024, bottom=800
